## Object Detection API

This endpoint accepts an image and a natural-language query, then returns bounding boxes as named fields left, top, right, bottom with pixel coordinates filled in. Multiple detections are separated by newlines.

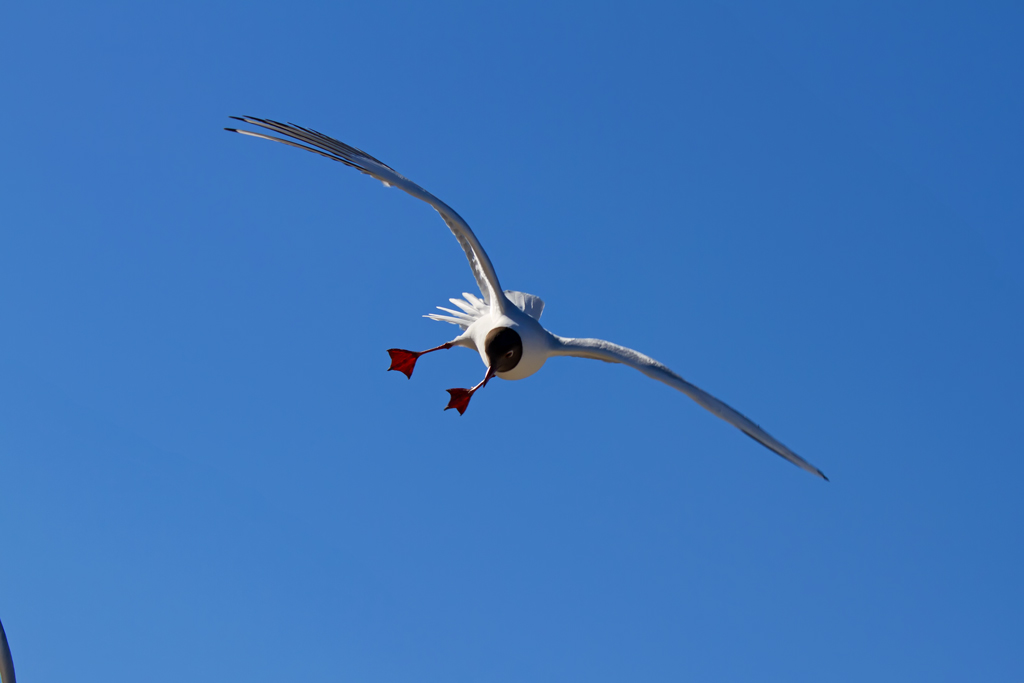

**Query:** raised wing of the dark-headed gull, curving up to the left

left=224, top=116, right=505, bottom=312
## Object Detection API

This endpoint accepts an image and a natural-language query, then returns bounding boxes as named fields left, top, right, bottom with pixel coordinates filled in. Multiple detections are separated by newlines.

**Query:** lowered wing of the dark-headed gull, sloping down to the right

left=552, top=337, right=828, bottom=481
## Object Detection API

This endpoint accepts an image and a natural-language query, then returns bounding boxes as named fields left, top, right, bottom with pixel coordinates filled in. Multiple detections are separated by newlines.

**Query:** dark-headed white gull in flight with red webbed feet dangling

left=224, top=117, right=828, bottom=481
